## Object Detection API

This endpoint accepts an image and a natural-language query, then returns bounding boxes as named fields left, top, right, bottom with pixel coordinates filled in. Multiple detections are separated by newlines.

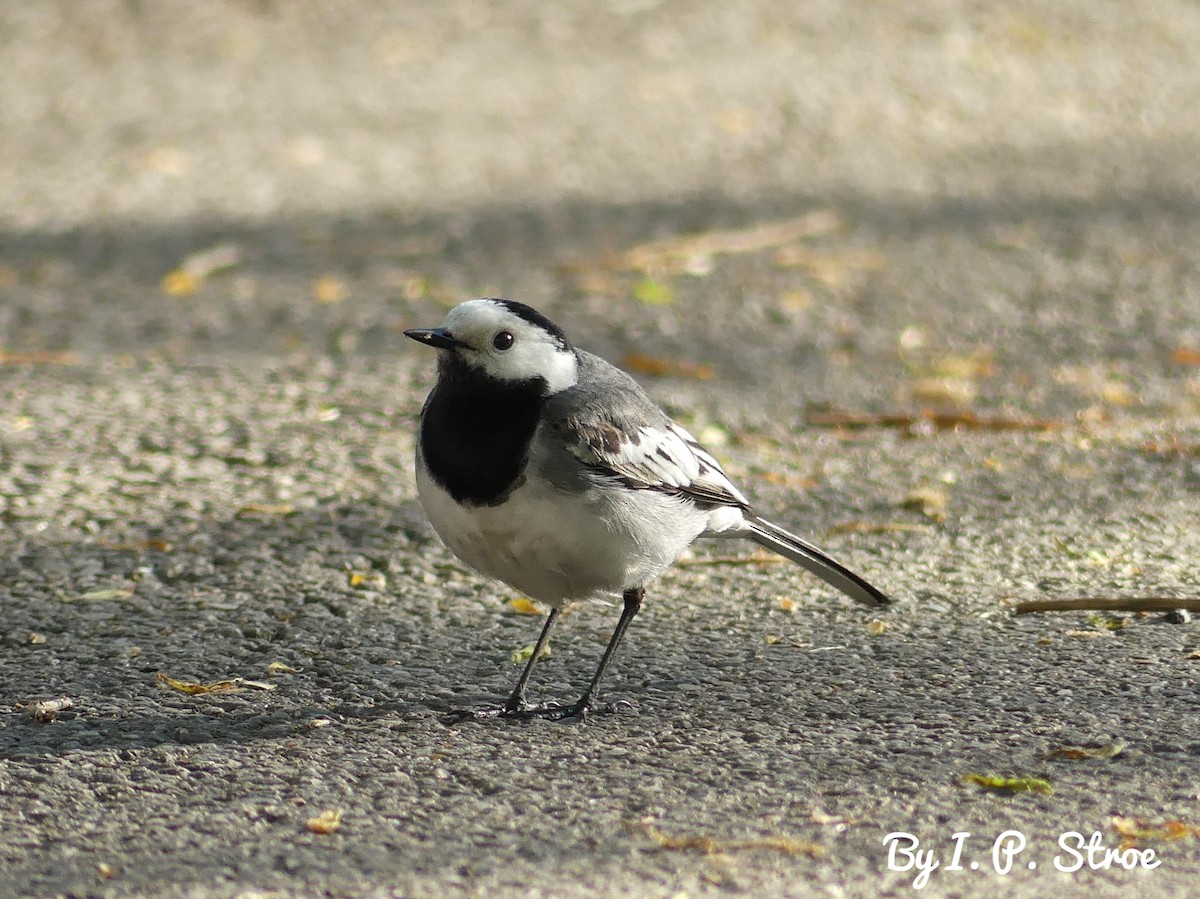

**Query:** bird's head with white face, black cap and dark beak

left=404, top=299, right=578, bottom=396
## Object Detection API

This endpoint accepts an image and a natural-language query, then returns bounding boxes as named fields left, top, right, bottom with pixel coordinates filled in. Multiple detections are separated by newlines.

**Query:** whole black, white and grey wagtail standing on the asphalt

left=404, top=299, right=890, bottom=719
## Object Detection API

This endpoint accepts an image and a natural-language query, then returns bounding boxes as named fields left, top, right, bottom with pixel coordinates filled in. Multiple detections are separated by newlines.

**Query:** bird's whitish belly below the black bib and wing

left=416, top=466, right=708, bottom=607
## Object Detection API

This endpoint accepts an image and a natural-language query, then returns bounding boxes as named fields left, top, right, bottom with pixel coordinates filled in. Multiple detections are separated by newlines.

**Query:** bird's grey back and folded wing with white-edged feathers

left=547, top=353, right=749, bottom=509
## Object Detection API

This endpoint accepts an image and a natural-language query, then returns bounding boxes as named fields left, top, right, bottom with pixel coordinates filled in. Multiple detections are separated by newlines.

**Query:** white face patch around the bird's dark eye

left=442, top=300, right=578, bottom=394
